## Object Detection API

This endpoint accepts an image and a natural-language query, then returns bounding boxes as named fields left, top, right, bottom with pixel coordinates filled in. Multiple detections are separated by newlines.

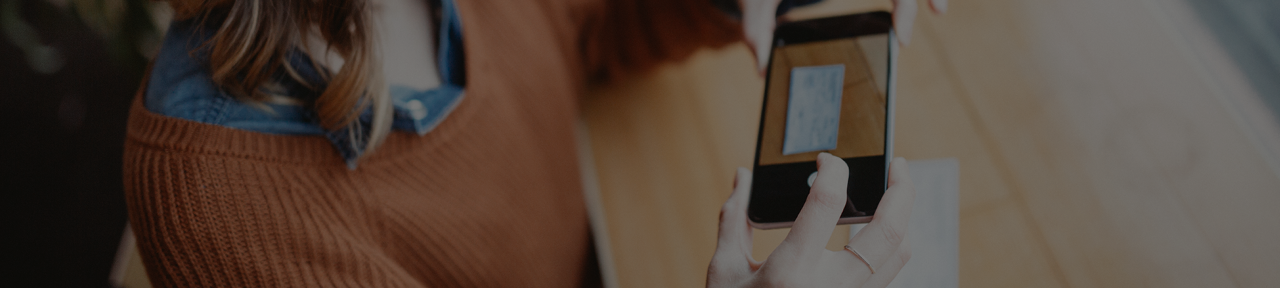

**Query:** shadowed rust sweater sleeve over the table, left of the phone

left=581, top=0, right=742, bottom=82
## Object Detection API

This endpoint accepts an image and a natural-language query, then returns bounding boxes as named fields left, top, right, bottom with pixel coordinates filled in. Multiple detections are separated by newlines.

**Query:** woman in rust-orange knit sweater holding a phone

left=124, top=0, right=947, bottom=287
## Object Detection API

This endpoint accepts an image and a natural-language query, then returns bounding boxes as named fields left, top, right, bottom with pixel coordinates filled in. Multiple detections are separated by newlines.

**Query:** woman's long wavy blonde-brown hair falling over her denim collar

left=169, top=0, right=392, bottom=160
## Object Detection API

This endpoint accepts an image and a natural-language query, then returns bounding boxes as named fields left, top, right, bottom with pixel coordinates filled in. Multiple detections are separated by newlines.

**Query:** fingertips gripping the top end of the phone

left=739, top=0, right=947, bottom=73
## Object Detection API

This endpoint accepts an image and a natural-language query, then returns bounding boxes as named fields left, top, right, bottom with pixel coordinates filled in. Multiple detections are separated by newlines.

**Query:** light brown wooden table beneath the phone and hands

left=582, top=0, right=1280, bottom=287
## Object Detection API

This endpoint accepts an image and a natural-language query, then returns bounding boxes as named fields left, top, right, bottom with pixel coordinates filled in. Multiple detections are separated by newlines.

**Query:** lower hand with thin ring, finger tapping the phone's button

left=707, top=154, right=915, bottom=288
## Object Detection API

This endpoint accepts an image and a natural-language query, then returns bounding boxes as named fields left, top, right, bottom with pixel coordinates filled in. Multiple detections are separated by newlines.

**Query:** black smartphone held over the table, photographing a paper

left=748, top=12, right=897, bottom=229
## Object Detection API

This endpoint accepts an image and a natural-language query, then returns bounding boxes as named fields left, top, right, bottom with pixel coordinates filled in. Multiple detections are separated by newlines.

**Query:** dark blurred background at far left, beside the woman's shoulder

left=0, top=0, right=155, bottom=287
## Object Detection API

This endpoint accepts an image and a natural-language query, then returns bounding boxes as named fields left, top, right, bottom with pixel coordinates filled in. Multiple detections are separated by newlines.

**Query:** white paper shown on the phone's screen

left=782, top=64, right=845, bottom=155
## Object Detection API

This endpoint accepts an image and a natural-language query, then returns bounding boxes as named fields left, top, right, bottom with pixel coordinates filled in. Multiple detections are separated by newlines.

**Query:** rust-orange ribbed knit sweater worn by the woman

left=124, top=0, right=737, bottom=287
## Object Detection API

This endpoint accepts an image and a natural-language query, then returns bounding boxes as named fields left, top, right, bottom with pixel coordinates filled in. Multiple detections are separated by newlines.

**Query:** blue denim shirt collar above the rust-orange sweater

left=143, top=0, right=466, bottom=169
